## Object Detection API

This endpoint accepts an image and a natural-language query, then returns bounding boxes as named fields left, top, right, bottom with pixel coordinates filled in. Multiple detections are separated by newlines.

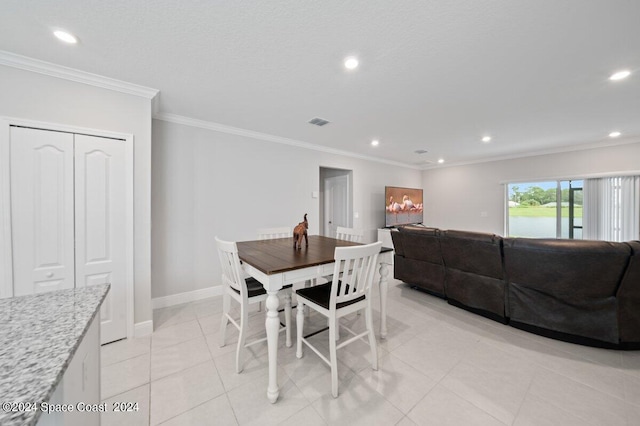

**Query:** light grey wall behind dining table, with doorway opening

left=152, top=120, right=422, bottom=298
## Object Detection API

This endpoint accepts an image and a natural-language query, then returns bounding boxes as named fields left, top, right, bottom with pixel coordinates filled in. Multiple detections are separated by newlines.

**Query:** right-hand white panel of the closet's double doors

left=75, top=135, right=127, bottom=343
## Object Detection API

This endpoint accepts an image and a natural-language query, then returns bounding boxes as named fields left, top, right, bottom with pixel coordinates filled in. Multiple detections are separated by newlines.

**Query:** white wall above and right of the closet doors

left=0, top=66, right=151, bottom=323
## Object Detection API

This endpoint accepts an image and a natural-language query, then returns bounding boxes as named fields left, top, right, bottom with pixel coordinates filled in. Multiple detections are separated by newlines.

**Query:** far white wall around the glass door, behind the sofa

left=422, top=143, right=640, bottom=235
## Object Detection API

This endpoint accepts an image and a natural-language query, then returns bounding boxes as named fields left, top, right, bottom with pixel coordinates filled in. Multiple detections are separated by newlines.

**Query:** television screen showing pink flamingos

left=384, top=186, right=422, bottom=228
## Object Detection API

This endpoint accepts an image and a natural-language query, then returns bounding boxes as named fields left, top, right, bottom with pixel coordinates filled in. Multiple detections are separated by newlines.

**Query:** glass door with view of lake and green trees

left=506, top=180, right=583, bottom=239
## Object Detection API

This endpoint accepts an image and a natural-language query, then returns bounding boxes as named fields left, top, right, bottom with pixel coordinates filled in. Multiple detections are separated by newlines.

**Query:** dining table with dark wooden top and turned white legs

left=237, top=235, right=393, bottom=403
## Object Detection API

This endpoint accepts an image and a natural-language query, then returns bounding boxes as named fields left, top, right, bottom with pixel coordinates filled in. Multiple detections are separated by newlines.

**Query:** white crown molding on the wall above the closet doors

left=0, top=50, right=159, bottom=99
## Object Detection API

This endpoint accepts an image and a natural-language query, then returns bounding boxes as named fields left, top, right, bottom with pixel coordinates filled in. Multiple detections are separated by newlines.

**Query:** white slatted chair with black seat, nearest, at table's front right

left=296, top=241, right=382, bottom=398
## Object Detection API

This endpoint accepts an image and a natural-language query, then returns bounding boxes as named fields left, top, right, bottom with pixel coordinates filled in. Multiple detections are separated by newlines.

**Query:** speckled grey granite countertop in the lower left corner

left=0, top=284, right=110, bottom=426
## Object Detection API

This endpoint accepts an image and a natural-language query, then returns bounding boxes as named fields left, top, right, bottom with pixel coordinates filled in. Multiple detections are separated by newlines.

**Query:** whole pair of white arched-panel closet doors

left=10, top=127, right=127, bottom=343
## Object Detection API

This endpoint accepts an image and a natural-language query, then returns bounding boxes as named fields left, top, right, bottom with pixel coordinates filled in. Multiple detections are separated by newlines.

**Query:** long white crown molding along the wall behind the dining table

left=153, top=112, right=420, bottom=170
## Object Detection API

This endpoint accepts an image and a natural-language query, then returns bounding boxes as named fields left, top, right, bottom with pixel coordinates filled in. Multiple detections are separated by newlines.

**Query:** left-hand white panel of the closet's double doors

left=10, top=127, right=75, bottom=296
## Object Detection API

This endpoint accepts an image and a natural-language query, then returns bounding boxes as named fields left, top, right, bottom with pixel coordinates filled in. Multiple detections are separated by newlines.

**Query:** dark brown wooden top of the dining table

left=237, top=235, right=361, bottom=275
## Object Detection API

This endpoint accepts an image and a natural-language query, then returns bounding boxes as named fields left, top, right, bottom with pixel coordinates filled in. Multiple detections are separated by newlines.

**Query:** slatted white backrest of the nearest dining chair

left=329, top=241, right=382, bottom=310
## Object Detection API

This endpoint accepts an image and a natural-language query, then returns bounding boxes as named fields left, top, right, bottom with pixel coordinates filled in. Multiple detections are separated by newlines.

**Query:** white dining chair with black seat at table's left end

left=216, top=237, right=291, bottom=373
